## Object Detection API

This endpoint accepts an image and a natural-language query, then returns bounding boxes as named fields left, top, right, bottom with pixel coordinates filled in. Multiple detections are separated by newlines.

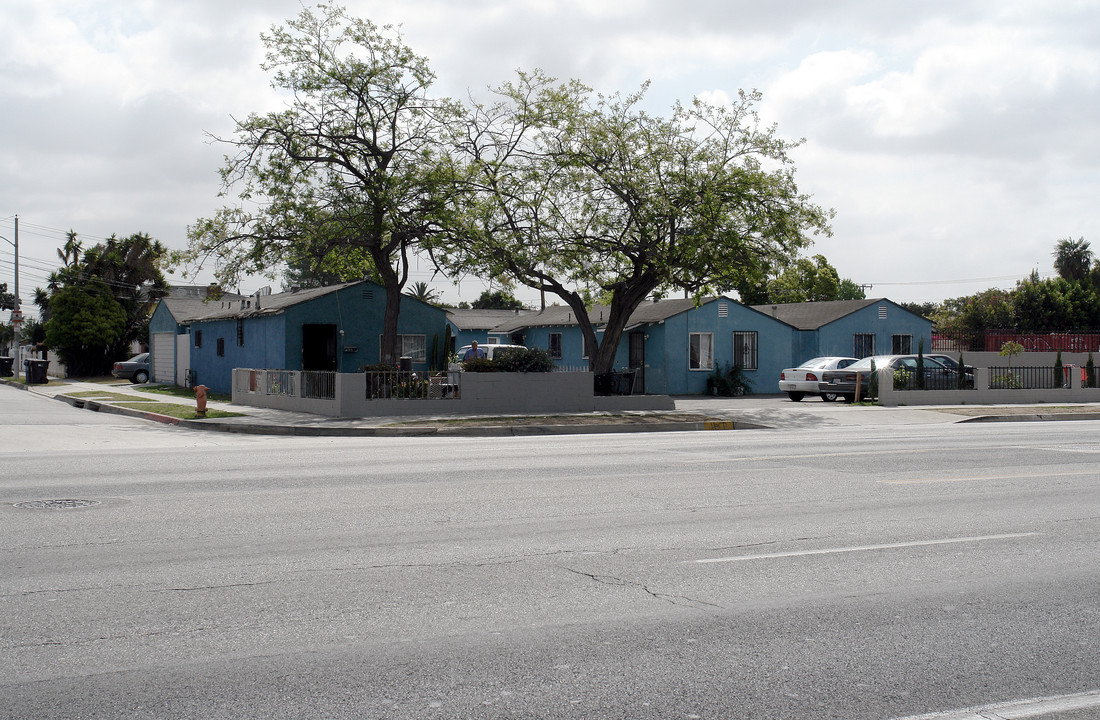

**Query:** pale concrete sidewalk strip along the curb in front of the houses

left=3, top=378, right=1100, bottom=436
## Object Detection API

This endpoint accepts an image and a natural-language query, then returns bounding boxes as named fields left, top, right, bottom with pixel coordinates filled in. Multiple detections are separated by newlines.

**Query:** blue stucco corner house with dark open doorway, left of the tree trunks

left=150, top=280, right=447, bottom=394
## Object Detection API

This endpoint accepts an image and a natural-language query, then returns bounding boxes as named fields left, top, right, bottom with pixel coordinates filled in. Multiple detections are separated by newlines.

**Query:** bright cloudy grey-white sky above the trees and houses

left=0, top=0, right=1100, bottom=316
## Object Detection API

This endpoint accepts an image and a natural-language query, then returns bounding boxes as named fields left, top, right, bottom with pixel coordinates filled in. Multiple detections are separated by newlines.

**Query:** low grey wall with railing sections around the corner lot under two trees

left=233, top=368, right=675, bottom=418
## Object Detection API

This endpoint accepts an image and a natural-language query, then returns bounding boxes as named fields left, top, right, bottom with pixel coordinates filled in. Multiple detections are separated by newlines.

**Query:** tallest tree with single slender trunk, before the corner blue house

left=176, top=5, right=462, bottom=364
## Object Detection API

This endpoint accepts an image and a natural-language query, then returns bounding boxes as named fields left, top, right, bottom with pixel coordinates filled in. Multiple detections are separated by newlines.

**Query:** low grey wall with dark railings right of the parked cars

left=878, top=367, right=1100, bottom=408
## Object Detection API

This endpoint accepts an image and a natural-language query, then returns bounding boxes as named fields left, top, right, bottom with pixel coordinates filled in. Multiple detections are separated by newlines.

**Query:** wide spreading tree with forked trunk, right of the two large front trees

left=437, top=73, right=831, bottom=373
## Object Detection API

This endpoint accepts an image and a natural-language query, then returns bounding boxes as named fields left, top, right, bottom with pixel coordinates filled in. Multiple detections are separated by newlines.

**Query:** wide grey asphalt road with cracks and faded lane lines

left=0, top=387, right=1100, bottom=720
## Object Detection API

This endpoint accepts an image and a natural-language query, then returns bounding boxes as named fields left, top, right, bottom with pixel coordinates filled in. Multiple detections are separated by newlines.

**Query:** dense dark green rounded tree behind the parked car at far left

left=45, top=280, right=127, bottom=376
